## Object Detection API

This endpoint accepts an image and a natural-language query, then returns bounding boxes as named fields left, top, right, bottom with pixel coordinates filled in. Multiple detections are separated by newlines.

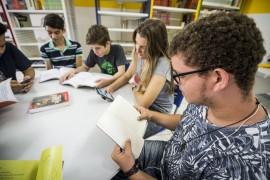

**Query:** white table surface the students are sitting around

left=0, top=79, right=135, bottom=180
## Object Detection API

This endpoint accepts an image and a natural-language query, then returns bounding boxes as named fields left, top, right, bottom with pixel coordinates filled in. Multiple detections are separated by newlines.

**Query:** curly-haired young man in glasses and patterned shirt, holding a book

left=112, top=12, right=270, bottom=180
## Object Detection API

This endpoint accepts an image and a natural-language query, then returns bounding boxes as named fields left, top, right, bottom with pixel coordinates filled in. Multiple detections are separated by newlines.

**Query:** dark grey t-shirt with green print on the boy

left=85, top=44, right=127, bottom=75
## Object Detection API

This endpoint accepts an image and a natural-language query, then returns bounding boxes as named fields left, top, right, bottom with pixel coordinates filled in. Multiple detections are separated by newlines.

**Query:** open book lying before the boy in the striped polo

left=39, top=67, right=73, bottom=82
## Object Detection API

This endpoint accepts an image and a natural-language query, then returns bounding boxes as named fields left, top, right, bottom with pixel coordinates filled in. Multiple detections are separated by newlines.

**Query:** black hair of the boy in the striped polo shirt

left=43, top=13, right=65, bottom=29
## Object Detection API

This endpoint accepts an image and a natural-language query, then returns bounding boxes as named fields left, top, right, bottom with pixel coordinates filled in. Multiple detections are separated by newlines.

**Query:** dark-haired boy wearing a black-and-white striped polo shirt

left=40, top=14, right=82, bottom=69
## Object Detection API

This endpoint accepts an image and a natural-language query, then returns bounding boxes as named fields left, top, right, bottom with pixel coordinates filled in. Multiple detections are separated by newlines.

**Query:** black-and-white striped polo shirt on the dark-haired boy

left=40, top=38, right=82, bottom=68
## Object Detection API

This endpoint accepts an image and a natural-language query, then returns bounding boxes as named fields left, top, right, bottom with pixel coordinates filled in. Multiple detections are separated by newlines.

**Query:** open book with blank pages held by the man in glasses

left=97, top=95, right=147, bottom=158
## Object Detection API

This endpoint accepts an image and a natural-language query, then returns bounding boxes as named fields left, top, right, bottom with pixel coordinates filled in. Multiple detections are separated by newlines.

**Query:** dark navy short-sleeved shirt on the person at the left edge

left=0, top=42, right=32, bottom=80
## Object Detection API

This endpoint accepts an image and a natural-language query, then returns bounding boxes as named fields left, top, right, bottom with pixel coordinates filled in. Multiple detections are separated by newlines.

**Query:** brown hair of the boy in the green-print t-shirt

left=86, top=24, right=110, bottom=46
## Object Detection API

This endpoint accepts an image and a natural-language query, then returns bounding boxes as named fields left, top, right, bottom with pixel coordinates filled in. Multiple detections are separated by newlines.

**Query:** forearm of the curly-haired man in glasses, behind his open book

left=150, top=111, right=182, bottom=131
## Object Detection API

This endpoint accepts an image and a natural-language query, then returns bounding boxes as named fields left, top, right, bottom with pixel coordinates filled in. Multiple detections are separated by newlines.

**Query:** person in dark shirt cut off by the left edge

left=0, top=23, right=35, bottom=93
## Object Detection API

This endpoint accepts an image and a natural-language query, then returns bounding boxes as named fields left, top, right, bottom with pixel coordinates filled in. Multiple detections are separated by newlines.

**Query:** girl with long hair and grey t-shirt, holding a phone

left=105, top=19, right=173, bottom=138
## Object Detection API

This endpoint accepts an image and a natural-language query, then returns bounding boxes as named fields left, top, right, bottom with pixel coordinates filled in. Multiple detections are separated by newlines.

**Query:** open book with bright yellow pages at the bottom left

left=0, top=145, right=63, bottom=180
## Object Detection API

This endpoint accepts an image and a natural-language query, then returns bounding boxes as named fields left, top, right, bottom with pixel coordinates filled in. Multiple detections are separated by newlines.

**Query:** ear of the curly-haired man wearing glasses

left=212, top=68, right=230, bottom=92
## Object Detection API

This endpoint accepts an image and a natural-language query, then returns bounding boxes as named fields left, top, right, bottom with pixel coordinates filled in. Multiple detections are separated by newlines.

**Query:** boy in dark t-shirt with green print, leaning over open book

left=61, top=25, right=127, bottom=88
